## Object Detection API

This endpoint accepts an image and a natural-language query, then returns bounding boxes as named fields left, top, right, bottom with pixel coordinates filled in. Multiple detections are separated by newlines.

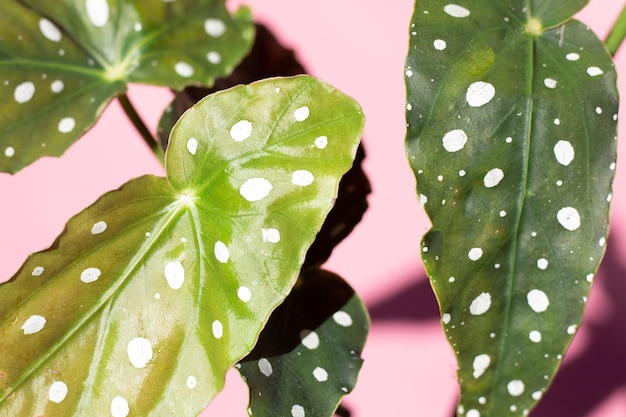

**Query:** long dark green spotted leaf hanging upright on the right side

left=406, top=0, right=618, bottom=417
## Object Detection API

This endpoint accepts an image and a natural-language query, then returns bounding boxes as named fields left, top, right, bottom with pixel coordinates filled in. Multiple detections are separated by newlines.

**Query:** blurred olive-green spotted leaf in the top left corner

left=0, top=0, right=254, bottom=172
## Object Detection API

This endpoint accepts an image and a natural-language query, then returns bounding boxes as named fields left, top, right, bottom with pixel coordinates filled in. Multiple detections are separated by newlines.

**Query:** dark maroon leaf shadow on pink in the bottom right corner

left=531, top=236, right=626, bottom=417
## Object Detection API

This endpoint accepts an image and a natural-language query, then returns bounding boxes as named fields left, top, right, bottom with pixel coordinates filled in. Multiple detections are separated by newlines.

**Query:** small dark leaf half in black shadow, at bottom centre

left=237, top=269, right=369, bottom=417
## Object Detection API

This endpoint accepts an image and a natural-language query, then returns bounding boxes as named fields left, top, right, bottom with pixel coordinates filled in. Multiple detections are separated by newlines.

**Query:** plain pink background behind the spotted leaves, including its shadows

left=0, top=0, right=626, bottom=417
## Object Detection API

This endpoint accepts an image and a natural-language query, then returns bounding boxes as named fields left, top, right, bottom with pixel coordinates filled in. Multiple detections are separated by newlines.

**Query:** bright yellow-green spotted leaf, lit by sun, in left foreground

left=0, top=76, right=363, bottom=417
